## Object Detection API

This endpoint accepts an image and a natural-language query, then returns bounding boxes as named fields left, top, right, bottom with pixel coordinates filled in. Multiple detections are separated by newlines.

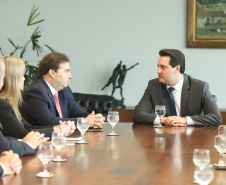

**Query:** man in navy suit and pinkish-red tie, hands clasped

left=21, top=52, right=104, bottom=128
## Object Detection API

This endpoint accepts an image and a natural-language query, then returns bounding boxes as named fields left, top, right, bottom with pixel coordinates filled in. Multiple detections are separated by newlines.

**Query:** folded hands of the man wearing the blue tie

left=161, top=116, right=187, bottom=127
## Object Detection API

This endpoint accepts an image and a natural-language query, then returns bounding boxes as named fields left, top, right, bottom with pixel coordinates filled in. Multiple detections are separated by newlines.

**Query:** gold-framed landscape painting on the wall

left=187, top=0, right=226, bottom=48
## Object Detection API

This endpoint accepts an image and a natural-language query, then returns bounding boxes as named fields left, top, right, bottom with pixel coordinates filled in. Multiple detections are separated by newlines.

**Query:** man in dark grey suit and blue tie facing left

left=133, top=49, right=222, bottom=126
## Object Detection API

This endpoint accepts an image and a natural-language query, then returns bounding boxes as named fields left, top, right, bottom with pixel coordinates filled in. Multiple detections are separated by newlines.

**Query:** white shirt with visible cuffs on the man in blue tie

left=154, top=75, right=195, bottom=125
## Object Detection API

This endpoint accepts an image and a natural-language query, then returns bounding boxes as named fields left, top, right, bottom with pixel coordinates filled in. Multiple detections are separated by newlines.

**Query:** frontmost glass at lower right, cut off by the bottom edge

left=194, top=164, right=214, bottom=185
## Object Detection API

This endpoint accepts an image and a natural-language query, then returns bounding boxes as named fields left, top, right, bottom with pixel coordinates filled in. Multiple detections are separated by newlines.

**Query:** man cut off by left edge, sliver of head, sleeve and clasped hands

left=0, top=58, right=49, bottom=156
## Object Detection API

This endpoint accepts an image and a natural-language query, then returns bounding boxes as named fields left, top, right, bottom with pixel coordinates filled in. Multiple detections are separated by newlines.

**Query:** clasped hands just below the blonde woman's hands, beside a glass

left=22, top=131, right=49, bottom=149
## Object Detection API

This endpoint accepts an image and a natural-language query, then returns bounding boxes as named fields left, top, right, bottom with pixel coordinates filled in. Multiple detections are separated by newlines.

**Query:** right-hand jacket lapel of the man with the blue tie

left=180, top=75, right=190, bottom=117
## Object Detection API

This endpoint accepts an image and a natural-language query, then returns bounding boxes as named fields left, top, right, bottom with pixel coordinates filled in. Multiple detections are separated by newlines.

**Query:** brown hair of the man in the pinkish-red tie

left=38, top=52, right=69, bottom=76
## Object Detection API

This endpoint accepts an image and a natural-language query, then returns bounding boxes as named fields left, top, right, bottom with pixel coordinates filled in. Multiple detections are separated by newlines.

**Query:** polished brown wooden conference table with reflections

left=0, top=123, right=226, bottom=185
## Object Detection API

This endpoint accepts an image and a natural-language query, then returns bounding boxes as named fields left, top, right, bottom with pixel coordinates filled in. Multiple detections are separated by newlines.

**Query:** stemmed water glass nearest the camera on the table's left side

left=36, top=143, right=53, bottom=177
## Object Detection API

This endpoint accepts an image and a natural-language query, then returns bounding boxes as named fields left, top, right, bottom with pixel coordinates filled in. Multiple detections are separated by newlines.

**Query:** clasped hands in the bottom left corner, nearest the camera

left=0, top=150, right=22, bottom=175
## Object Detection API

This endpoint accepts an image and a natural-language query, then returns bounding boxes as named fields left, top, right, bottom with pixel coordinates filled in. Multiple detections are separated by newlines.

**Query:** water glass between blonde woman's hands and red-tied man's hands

left=76, top=118, right=89, bottom=144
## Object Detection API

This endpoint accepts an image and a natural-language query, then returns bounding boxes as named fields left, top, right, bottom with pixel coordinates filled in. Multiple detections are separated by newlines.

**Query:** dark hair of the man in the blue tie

left=159, top=49, right=185, bottom=74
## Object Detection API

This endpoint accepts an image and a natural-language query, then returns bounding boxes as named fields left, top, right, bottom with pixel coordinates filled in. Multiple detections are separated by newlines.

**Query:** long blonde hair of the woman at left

left=0, top=56, right=25, bottom=123
